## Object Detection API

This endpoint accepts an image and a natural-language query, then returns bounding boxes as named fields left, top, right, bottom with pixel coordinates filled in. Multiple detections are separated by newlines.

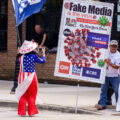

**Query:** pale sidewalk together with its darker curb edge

left=0, top=80, right=119, bottom=114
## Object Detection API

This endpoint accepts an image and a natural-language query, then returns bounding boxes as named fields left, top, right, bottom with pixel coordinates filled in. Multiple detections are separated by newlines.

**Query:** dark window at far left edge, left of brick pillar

left=0, top=0, right=8, bottom=51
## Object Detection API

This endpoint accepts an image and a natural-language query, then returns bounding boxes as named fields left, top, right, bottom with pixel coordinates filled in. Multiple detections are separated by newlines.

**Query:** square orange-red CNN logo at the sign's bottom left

left=59, top=61, right=70, bottom=74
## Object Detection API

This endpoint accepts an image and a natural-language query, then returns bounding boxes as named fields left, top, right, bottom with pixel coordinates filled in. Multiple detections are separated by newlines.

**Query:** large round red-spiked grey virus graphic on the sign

left=64, top=28, right=101, bottom=67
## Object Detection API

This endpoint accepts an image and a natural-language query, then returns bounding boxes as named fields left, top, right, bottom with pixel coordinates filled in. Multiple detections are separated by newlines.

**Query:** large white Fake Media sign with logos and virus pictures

left=54, top=0, right=114, bottom=83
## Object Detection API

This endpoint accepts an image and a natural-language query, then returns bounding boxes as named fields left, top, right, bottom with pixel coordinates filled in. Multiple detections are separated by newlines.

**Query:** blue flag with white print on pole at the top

left=12, top=0, right=46, bottom=26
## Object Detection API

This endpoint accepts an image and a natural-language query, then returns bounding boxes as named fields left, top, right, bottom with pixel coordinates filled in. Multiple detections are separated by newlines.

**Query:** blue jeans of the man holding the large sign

left=100, top=77, right=119, bottom=107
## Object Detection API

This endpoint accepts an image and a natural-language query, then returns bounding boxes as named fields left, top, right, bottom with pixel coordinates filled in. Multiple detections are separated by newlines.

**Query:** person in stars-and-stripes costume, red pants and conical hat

left=16, top=40, right=46, bottom=116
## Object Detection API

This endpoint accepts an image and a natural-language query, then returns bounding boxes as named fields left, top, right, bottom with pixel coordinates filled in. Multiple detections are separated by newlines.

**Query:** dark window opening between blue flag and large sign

left=26, top=0, right=63, bottom=48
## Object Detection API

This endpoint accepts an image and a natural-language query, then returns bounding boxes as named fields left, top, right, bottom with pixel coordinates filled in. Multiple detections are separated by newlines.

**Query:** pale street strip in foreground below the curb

left=0, top=107, right=120, bottom=120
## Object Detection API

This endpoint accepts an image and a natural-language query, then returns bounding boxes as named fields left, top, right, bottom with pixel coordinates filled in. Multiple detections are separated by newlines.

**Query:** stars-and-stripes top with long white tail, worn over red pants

left=16, top=54, right=46, bottom=100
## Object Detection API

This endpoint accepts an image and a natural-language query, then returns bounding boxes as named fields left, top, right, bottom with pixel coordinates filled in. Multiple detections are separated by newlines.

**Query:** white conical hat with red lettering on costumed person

left=19, top=40, right=38, bottom=54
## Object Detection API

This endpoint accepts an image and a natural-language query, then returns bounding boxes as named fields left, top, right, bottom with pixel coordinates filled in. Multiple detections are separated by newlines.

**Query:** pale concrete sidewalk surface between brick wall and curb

left=0, top=81, right=100, bottom=107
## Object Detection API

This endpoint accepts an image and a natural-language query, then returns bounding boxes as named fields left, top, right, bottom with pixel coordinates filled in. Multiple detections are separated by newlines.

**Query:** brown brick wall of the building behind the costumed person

left=0, top=0, right=101, bottom=84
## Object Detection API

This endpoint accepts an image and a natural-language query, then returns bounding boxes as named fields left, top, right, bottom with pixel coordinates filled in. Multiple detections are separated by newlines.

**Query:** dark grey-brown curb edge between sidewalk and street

left=0, top=101, right=100, bottom=115
